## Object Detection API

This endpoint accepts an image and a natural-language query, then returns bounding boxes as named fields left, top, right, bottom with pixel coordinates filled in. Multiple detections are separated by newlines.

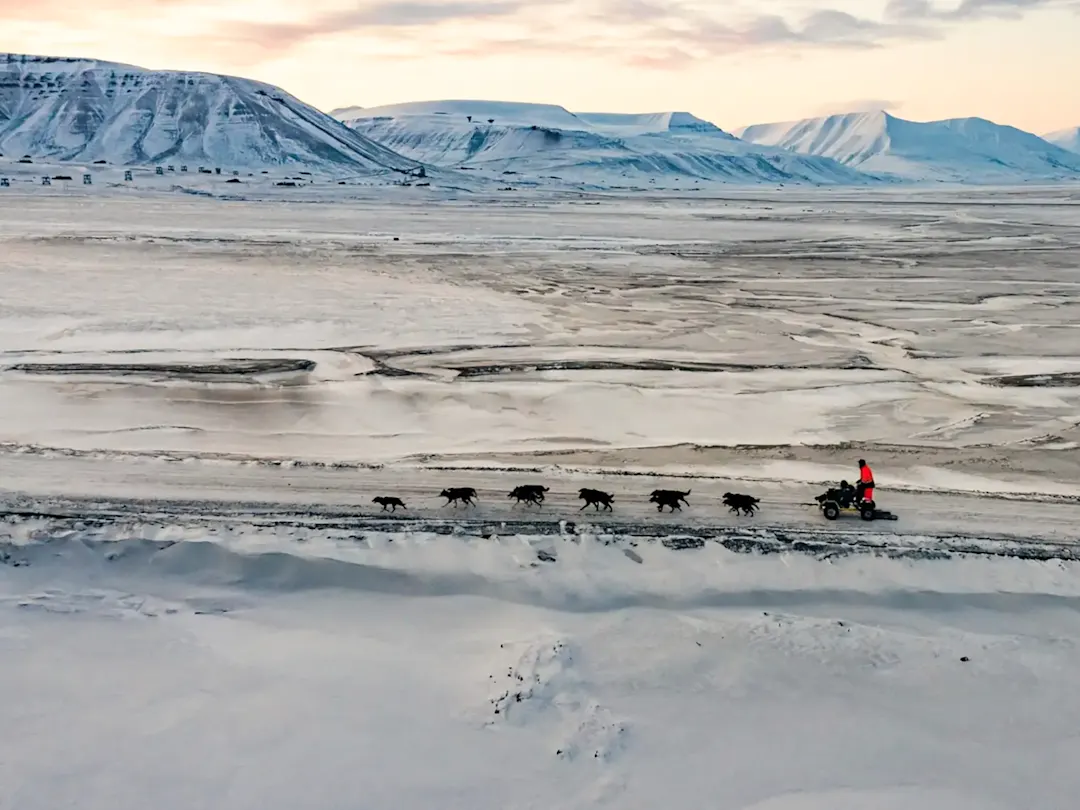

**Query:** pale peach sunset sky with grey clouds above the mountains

left=0, top=0, right=1080, bottom=134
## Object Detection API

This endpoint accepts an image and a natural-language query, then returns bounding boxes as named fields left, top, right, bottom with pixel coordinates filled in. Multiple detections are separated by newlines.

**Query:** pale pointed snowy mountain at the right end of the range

left=738, top=111, right=1080, bottom=183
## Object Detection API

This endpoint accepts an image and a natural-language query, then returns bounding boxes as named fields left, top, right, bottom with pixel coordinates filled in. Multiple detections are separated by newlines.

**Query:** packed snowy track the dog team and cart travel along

left=0, top=454, right=1080, bottom=558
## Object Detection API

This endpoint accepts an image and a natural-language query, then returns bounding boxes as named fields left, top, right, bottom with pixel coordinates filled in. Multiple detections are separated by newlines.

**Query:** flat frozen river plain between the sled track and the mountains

left=0, top=182, right=1080, bottom=495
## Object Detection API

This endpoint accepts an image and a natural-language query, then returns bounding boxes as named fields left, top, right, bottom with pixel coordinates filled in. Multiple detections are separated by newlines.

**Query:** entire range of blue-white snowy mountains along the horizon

left=0, top=54, right=1080, bottom=189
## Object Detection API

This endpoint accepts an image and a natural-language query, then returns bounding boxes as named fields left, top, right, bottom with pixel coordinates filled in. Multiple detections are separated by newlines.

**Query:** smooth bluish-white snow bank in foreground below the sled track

left=0, top=518, right=1080, bottom=810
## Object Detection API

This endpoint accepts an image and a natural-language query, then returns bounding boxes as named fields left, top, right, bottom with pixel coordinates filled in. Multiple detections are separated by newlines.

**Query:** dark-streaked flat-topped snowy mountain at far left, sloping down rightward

left=0, top=54, right=417, bottom=172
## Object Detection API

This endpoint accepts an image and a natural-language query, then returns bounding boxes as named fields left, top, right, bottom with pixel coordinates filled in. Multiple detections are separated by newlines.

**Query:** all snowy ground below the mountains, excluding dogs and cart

left=0, top=182, right=1080, bottom=810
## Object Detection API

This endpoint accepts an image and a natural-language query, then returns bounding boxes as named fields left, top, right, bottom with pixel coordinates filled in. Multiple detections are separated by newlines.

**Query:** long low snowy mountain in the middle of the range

left=338, top=100, right=874, bottom=185
